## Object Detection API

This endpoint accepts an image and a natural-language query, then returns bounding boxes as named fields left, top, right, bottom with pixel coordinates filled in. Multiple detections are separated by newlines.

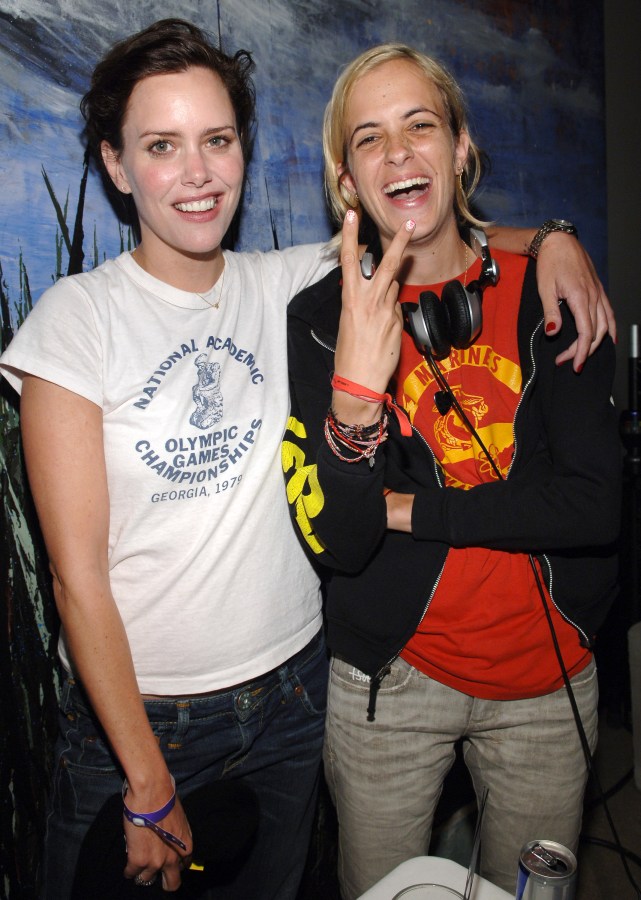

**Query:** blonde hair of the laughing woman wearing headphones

left=323, top=43, right=488, bottom=243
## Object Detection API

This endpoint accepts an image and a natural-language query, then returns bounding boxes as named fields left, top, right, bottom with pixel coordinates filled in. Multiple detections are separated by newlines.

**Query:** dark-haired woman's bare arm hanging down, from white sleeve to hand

left=20, top=375, right=191, bottom=890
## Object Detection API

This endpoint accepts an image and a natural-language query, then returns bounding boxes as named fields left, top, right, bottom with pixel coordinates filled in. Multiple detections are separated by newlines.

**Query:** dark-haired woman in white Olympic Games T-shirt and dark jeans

left=1, top=19, right=606, bottom=900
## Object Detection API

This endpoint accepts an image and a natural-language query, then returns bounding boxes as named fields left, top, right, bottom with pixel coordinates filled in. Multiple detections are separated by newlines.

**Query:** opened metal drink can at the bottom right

left=515, top=841, right=576, bottom=900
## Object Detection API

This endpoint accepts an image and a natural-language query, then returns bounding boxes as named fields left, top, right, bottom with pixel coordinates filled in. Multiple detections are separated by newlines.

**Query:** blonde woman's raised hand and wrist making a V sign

left=332, top=210, right=415, bottom=425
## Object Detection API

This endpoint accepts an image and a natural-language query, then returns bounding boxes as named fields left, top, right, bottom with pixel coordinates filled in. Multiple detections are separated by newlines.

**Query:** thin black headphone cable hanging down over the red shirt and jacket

left=424, top=350, right=641, bottom=898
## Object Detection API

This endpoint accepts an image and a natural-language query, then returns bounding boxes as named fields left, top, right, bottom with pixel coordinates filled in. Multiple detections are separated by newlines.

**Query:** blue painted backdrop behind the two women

left=0, top=0, right=606, bottom=312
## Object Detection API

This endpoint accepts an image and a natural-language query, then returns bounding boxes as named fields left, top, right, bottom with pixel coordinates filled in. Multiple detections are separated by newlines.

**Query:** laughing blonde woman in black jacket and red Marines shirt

left=284, top=44, right=621, bottom=900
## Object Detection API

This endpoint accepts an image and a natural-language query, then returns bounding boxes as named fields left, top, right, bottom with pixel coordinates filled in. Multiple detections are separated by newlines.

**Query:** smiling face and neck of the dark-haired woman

left=102, top=67, right=244, bottom=290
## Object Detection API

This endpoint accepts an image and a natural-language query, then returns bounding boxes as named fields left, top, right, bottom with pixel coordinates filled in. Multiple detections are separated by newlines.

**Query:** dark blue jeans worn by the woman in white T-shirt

left=41, top=633, right=328, bottom=900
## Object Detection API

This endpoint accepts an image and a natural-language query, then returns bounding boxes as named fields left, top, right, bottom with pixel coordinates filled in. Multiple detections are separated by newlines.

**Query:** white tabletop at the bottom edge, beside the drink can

left=360, top=856, right=516, bottom=900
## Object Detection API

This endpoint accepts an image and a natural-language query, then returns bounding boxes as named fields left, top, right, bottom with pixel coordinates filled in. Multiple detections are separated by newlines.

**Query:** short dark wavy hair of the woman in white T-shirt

left=80, top=19, right=256, bottom=175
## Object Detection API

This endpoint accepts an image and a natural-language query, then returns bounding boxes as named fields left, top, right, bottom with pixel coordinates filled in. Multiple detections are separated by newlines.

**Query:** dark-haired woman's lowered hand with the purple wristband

left=123, top=793, right=193, bottom=891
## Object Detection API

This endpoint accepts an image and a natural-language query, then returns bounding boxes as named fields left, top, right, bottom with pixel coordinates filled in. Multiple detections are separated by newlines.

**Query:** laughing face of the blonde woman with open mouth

left=342, top=59, right=469, bottom=250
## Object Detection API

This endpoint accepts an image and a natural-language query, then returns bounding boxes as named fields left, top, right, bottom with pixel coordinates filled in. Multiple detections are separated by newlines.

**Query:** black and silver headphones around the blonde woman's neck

left=404, top=228, right=499, bottom=359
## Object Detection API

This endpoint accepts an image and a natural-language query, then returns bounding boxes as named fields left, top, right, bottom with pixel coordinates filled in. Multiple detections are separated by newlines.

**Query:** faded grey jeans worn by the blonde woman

left=324, top=659, right=598, bottom=900
